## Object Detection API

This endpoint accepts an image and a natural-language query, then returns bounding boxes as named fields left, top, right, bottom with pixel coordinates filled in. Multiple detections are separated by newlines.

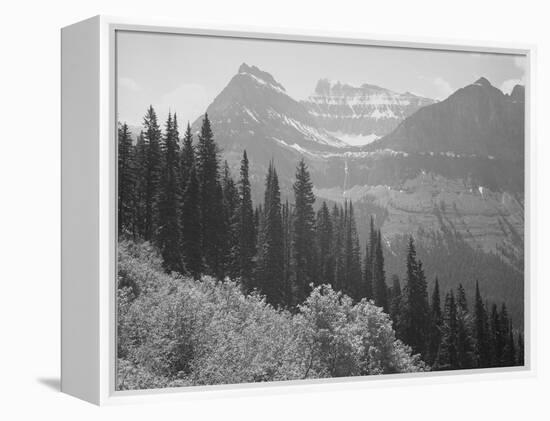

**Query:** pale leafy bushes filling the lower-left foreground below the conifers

left=117, top=242, right=425, bottom=390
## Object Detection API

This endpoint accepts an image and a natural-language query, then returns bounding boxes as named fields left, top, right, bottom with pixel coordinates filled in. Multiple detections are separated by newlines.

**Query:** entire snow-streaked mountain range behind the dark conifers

left=193, top=64, right=525, bottom=317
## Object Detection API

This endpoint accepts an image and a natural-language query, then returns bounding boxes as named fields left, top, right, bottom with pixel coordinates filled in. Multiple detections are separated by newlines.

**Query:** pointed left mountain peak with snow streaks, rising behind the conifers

left=193, top=63, right=348, bottom=194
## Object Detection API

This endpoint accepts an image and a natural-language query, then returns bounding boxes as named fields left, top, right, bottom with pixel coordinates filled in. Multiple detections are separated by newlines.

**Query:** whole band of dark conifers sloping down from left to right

left=118, top=107, right=523, bottom=369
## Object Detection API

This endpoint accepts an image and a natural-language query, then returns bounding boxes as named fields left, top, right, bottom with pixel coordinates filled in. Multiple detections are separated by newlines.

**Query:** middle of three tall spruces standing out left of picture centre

left=256, top=162, right=285, bottom=306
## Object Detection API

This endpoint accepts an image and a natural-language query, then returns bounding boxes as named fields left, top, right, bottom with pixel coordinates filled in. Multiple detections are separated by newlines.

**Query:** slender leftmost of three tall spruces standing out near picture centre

left=237, top=151, right=256, bottom=290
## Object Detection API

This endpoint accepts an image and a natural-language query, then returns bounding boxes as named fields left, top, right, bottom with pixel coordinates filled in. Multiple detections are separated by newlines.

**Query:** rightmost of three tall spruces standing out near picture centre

left=292, top=159, right=316, bottom=303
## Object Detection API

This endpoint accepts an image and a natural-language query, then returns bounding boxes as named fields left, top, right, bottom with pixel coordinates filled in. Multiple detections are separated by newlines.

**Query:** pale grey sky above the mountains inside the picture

left=117, top=32, right=526, bottom=125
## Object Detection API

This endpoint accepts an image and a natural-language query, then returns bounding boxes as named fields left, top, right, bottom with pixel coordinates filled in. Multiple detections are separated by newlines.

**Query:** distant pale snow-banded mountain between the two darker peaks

left=302, top=79, right=435, bottom=146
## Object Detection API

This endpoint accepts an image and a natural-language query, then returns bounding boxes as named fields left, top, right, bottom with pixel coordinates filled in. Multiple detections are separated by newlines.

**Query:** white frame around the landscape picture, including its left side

left=61, top=16, right=536, bottom=405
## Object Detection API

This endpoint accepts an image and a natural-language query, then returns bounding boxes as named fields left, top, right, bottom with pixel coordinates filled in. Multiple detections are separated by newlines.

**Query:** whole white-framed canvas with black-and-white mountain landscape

left=61, top=16, right=534, bottom=404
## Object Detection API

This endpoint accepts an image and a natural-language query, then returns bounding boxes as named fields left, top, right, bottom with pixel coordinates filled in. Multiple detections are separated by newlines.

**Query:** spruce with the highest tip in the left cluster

left=143, top=106, right=162, bottom=241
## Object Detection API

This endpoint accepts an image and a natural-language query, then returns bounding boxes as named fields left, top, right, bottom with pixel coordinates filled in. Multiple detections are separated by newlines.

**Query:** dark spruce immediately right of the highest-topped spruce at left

left=157, top=113, right=184, bottom=273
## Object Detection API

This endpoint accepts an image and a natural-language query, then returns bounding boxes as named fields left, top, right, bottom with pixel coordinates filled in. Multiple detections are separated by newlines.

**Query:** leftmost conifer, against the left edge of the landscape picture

left=118, top=123, right=135, bottom=235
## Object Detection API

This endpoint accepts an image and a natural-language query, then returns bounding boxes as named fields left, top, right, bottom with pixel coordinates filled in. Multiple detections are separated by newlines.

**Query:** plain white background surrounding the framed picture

left=0, top=0, right=550, bottom=420
